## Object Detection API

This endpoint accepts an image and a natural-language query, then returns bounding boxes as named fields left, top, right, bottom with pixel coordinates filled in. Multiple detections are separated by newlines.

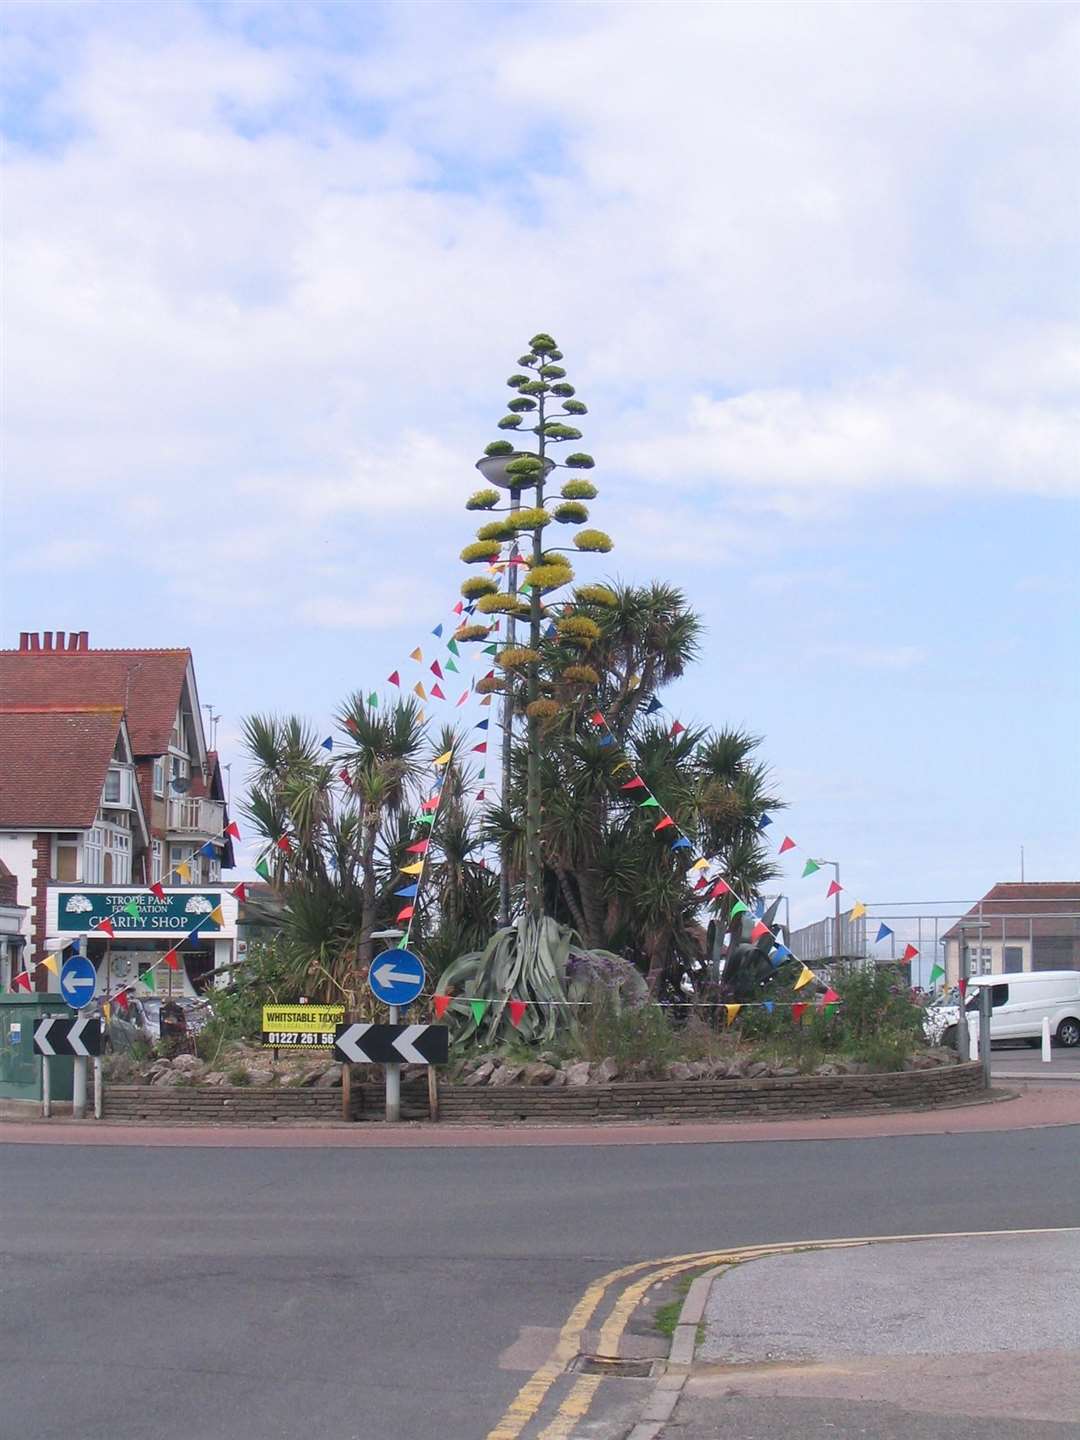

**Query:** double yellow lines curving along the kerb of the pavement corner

left=485, top=1225, right=1079, bottom=1440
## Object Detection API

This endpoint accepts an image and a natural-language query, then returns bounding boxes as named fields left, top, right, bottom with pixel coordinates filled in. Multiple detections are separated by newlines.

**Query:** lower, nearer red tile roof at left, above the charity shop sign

left=0, top=704, right=122, bottom=829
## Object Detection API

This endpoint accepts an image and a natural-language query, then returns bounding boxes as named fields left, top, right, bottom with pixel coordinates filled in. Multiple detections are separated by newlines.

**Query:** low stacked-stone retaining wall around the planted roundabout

left=105, top=1064, right=984, bottom=1125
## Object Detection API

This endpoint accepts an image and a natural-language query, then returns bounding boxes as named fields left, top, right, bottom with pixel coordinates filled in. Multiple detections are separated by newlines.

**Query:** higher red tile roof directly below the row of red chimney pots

left=0, top=649, right=194, bottom=755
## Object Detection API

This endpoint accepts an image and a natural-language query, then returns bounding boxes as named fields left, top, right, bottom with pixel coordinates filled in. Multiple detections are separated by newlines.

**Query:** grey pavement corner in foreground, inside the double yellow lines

left=650, top=1230, right=1080, bottom=1440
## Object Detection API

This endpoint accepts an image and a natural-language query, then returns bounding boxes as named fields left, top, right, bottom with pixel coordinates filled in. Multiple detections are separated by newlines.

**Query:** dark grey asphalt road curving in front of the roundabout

left=0, top=1128, right=1080, bottom=1440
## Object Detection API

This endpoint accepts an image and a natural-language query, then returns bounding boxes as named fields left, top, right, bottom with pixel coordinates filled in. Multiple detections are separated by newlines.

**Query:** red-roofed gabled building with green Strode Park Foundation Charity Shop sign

left=0, top=631, right=235, bottom=988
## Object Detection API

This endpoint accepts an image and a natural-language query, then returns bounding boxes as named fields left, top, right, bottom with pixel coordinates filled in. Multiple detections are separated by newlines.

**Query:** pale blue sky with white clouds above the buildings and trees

left=0, top=0, right=1080, bottom=922
